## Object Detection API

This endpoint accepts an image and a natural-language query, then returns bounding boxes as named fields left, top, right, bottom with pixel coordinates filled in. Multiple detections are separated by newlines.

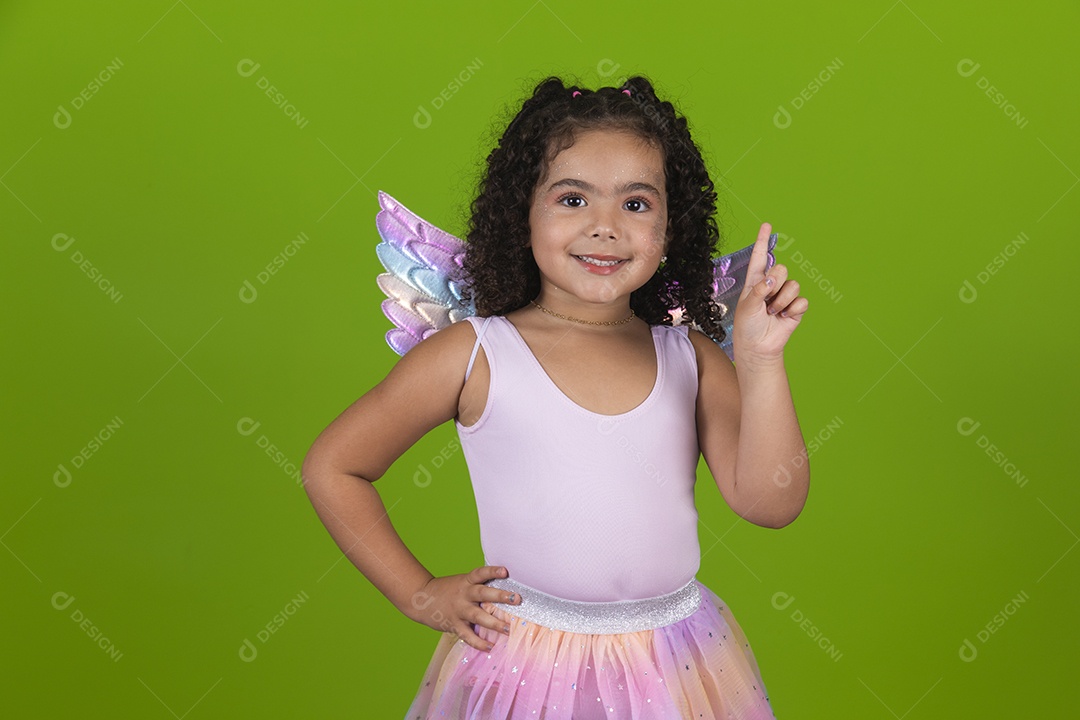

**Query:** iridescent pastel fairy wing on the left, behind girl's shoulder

left=375, top=190, right=476, bottom=355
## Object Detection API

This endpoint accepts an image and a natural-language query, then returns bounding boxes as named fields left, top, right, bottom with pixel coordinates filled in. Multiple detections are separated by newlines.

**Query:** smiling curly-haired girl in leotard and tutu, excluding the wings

left=303, top=77, right=809, bottom=720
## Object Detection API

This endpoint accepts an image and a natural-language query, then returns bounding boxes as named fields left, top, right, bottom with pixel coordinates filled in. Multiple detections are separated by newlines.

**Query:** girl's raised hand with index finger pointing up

left=732, top=222, right=810, bottom=363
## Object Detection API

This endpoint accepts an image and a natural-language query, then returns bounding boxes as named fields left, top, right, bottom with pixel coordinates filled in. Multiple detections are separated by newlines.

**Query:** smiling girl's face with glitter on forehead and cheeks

left=529, top=130, right=667, bottom=314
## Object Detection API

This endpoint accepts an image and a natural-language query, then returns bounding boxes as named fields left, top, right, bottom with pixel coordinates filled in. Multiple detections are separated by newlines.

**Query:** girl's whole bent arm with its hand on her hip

left=301, top=323, right=520, bottom=648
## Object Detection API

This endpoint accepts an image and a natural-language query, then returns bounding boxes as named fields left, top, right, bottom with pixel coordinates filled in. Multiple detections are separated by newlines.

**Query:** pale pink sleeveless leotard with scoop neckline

left=456, top=316, right=701, bottom=601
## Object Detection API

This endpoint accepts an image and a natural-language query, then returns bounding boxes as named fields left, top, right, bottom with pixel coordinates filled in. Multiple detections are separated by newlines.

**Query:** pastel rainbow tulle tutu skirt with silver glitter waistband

left=405, top=579, right=774, bottom=720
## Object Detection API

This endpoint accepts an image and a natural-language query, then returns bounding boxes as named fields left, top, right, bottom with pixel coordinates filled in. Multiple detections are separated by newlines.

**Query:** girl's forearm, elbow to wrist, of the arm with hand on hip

left=303, top=471, right=432, bottom=619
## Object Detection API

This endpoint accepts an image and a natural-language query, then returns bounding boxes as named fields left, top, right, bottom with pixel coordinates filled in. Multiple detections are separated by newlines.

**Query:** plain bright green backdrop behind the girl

left=0, top=0, right=1080, bottom=720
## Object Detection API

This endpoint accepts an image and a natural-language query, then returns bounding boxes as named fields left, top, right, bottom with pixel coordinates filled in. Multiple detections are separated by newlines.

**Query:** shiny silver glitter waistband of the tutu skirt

left=487, top=578, right=701, bottom=635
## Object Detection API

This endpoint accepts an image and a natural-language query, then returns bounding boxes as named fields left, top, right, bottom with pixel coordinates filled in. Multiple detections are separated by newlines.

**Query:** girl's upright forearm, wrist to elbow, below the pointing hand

left=734, top=357, right=810, bottom=528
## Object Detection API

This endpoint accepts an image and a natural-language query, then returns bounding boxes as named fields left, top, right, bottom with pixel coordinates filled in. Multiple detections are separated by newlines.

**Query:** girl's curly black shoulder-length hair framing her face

left=462, top=76, right=725, bottom=342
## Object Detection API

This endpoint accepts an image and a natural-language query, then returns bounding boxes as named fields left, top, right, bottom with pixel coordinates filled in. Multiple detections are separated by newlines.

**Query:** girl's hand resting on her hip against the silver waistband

left=405, top=566, right=522, bottom=651
